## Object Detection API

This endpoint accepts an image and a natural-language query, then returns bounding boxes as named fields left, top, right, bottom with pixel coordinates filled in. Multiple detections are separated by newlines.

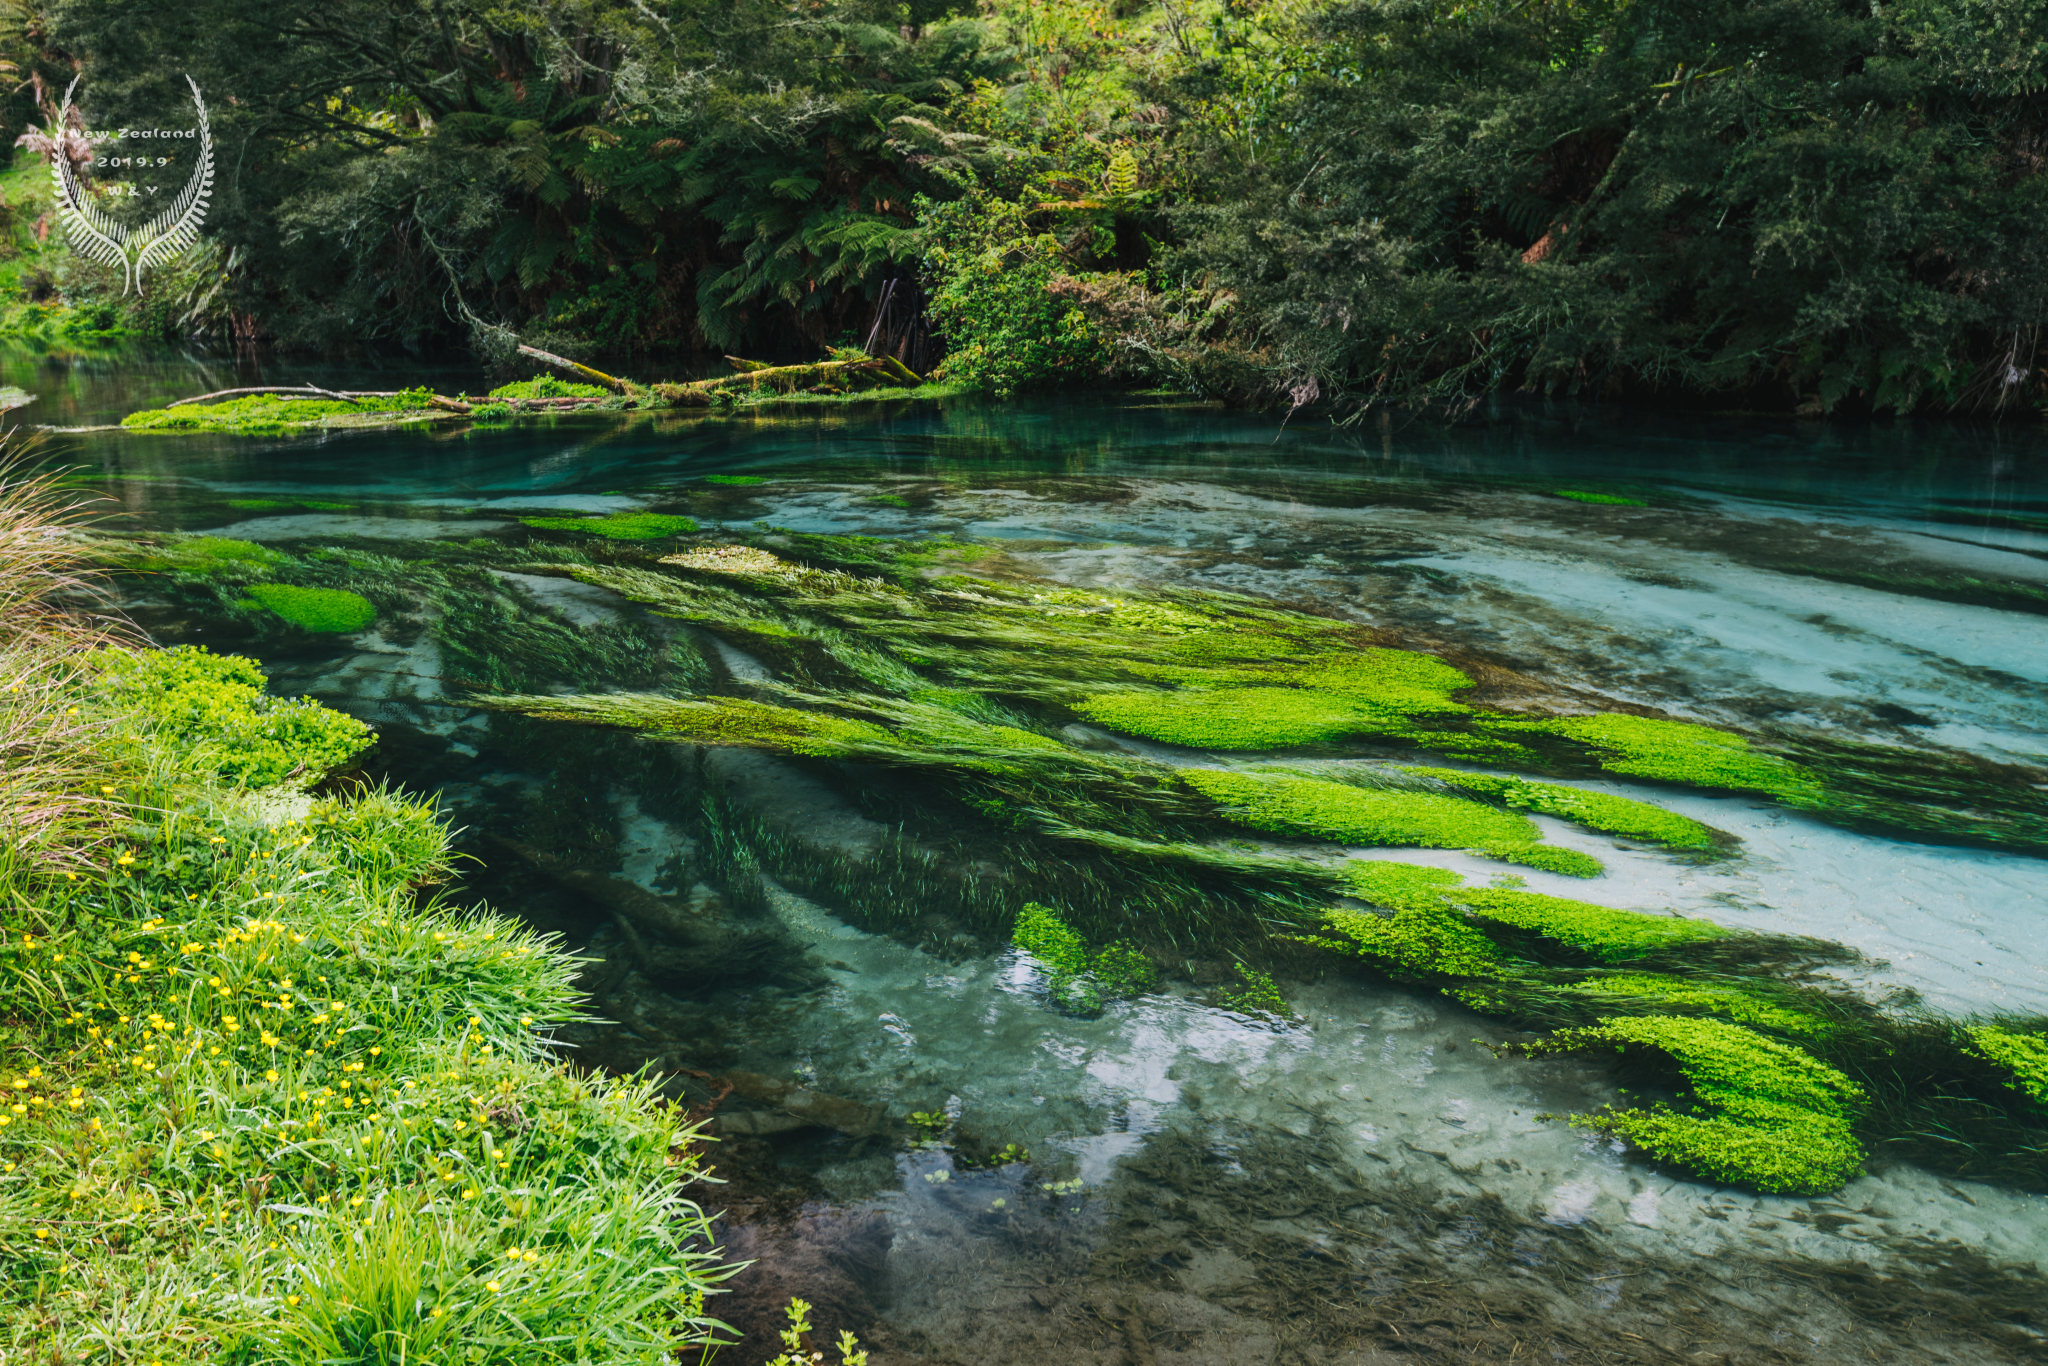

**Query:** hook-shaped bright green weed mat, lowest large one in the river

left=1509, top=1016, right=1866, bottom=1196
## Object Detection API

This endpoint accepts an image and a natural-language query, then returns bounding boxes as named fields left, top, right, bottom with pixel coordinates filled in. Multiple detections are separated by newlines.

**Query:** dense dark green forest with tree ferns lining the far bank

left=0, top=0, right=2048, bottom=416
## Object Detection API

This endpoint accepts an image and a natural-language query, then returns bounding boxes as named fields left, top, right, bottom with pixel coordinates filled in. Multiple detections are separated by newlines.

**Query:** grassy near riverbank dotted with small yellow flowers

left=0, top=469, right=737, bottom=1364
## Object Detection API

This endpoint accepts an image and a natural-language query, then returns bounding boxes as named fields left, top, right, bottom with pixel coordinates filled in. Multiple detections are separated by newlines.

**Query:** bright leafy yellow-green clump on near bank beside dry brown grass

left=94, top=645, right=373, bottom=786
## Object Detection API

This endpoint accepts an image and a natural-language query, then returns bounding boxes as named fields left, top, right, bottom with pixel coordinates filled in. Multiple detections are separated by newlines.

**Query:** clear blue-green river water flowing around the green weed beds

left=28, top=356, right=2048, bottom=1366
